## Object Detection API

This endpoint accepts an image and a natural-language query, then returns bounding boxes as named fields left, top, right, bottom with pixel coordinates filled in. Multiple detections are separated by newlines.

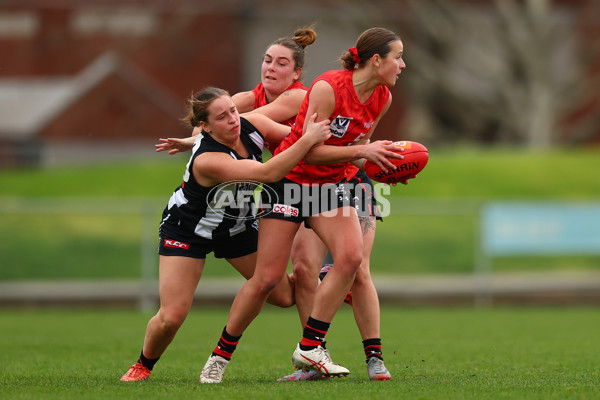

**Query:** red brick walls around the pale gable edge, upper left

left=0, top=1, right=242, bottom=140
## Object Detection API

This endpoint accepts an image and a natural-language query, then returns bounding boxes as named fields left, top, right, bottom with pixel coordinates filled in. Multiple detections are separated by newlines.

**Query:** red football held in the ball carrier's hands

left=364, top=141, right=429, bottom=183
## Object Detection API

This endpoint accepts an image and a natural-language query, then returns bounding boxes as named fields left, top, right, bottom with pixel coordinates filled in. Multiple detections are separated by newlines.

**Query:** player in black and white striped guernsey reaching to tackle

left=121, top=88, right=331, bottom=381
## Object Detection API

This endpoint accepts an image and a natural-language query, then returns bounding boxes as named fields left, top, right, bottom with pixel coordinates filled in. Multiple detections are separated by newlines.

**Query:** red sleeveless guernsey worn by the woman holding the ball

left=275, top=70, right=390, bottom=184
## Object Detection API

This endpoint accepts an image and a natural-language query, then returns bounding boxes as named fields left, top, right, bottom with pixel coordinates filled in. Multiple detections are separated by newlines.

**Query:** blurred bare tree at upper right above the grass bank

left=390, top=0, right=600, bottom=149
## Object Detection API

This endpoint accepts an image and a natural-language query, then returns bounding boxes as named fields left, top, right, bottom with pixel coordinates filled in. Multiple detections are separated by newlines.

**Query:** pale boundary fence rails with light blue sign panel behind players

left=0, top=197, right=600, bottom=312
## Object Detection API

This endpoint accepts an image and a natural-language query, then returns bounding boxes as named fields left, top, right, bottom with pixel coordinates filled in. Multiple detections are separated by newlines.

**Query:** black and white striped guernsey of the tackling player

left=160, top=118, right=264, bottom=240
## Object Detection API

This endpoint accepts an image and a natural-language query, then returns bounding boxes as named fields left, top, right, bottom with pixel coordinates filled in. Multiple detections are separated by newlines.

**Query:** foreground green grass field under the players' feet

left=0, top=306, right=600, bottom=400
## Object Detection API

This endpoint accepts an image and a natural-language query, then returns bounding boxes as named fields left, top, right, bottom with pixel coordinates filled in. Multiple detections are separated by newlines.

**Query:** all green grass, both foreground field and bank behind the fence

left=0, top=149, right=600, bottom=400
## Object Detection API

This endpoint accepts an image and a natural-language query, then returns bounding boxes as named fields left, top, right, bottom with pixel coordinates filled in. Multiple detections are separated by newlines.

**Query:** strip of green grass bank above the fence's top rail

left=0, top=148, right=600, bottom=198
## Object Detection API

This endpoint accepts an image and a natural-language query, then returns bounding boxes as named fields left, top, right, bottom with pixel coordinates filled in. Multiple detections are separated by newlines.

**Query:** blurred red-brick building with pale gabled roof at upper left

left=0, top=0, right=241, bottom=165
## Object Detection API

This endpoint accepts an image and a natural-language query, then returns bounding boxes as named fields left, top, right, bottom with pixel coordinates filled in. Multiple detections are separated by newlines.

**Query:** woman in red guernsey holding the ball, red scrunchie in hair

left=200, top=28, right=405, bottom=383
